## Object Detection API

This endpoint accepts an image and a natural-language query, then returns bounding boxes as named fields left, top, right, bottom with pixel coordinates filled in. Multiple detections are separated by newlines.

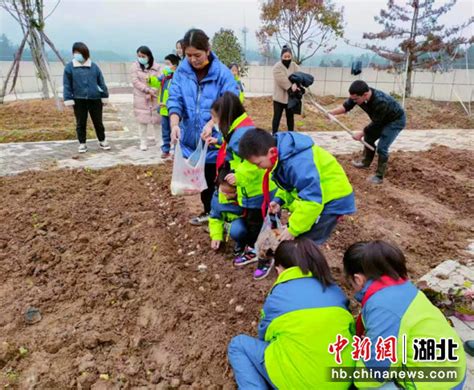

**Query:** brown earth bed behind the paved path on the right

left=244, top=96, right=474, bottom=131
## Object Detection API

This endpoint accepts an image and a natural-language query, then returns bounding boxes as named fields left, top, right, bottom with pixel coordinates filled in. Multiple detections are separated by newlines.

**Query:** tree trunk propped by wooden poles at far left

left=0, top=0, right=65, bottom=103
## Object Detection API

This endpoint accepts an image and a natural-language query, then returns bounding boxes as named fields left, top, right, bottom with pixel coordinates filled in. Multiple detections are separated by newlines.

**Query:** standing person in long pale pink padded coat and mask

left=131, top=46, right=161, bottom=150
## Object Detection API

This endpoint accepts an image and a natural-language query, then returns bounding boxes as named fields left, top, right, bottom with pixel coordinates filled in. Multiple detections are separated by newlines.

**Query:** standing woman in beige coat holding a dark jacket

left=272, top=45, right=300, bottom=134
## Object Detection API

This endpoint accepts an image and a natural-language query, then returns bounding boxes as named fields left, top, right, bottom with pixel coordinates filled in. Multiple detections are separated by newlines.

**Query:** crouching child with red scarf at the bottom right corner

left=343, top=240, right=466, bottom=390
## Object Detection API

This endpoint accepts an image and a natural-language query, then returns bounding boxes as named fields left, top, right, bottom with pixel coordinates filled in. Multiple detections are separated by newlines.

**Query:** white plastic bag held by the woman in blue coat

left=171, top=141, right=207, bottom=195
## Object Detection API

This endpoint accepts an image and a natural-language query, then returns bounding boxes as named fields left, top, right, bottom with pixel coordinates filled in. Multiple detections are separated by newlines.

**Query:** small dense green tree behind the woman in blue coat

left=212, top=28, right=247, bottom=75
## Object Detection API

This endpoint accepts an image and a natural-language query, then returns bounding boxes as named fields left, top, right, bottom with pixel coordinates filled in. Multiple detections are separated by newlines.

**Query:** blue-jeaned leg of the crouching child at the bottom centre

left=227, top=334, right=274, bottom=390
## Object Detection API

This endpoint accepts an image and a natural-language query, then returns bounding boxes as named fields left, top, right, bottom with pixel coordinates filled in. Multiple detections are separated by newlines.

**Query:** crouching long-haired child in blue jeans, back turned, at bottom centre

left=228, top=238, right=354, bottom=390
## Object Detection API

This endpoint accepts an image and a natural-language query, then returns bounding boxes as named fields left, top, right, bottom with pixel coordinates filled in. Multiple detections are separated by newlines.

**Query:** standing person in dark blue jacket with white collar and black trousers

left=63, top=42, right=110, bottom=153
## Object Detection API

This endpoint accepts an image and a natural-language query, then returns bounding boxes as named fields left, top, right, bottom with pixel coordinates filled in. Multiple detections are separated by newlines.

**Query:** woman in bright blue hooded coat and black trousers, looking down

left=166, top=29, right=239, bottom=225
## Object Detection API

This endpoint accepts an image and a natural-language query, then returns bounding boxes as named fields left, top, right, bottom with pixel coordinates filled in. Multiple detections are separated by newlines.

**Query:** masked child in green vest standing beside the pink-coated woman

left=149, top=54, right=179, bottom=159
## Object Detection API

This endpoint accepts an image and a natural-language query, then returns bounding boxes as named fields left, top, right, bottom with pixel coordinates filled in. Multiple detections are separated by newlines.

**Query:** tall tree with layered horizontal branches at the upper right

left=363, top=0, right=474, bottom=97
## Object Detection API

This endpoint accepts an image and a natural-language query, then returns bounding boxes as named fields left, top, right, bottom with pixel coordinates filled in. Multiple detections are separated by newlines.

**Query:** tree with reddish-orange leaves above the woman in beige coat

left=257, top=0, right=344, bottom=64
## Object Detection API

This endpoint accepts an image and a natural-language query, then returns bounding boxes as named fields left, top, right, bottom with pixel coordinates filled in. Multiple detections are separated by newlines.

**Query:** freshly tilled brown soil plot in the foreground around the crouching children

left=0, top=147, right=474, bottom=389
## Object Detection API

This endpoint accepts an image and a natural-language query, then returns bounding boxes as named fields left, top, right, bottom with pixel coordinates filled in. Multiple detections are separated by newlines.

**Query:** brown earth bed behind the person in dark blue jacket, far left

left=0, top=99, right=116, bottom=143
